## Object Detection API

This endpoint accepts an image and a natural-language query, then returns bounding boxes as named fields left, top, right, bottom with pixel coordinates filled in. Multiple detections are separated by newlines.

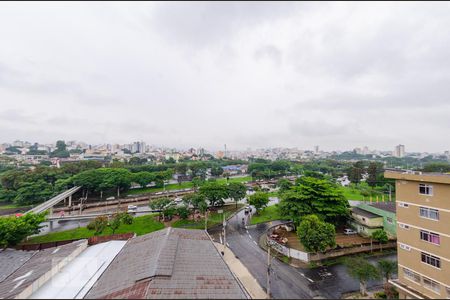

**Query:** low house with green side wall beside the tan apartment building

left=352, top=202, right=397, bottom=239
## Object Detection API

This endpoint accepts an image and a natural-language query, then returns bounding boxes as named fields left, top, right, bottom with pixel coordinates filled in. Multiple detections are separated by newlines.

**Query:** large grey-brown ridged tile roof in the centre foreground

left=86, top=228, right=245, bottom=299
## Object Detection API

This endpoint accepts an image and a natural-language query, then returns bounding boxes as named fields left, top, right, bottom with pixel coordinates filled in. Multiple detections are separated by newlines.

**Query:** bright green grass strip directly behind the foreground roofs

left=26, top=214, right=164, bottom=244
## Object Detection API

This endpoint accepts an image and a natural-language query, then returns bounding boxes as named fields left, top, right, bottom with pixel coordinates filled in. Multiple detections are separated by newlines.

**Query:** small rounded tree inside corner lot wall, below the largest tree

left=297, top=215, right=336, bottom=252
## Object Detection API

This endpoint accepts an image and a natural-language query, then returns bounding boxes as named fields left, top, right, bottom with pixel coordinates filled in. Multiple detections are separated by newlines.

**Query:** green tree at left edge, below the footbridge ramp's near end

left=0, top=212, right=46, bottom=248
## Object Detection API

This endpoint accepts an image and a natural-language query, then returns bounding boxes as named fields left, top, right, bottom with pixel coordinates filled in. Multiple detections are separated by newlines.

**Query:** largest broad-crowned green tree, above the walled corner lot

left=279, top=177, right=349, bottom=224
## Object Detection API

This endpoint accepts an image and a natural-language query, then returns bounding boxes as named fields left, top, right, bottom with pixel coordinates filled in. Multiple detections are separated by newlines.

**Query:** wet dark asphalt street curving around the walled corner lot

left=210, top=207, right=397, bottom=299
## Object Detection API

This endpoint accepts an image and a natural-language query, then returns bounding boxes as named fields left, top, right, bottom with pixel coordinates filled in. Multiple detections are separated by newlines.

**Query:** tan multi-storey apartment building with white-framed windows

left=384, top=171, right=450, bottom=299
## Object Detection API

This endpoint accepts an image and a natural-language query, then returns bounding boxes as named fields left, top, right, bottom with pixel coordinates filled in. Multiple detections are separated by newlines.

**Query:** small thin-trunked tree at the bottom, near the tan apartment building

left=344, top=257, right=380, bottom=296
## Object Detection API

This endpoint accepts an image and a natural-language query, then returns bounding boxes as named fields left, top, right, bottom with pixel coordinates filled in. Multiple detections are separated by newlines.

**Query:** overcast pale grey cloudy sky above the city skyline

left=0, top=2, right=450, bottom=151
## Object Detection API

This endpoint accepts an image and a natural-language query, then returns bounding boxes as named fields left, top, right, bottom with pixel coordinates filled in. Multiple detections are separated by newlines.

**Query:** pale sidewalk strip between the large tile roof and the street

left=214, top=242, right=267, bottom=299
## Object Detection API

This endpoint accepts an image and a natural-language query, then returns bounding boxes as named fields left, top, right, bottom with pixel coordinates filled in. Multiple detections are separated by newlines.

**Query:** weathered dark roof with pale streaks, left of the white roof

left=0, top=240, right=87, bottom=299
